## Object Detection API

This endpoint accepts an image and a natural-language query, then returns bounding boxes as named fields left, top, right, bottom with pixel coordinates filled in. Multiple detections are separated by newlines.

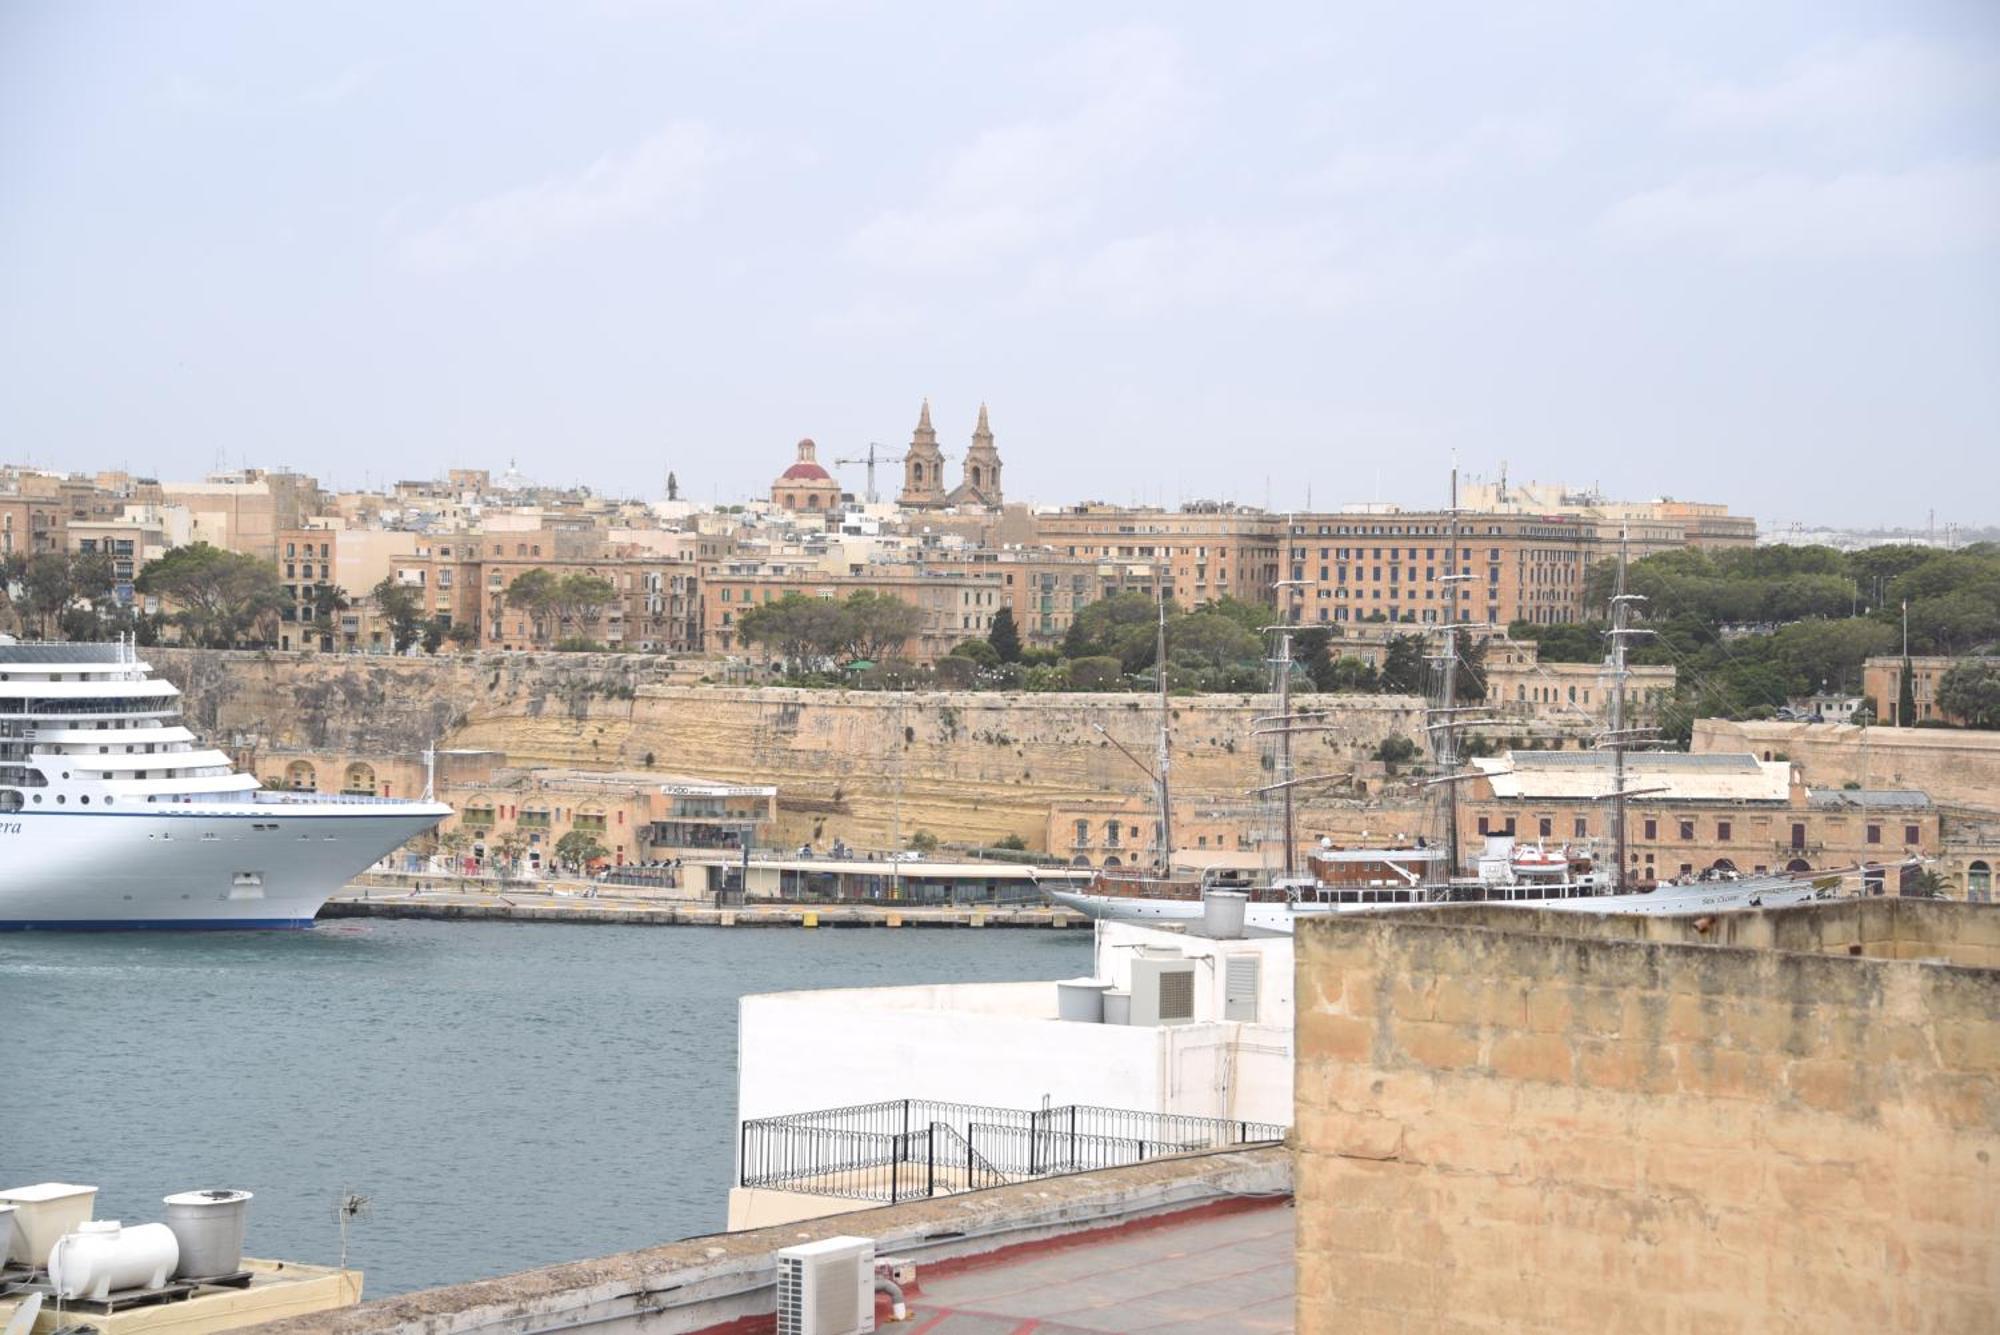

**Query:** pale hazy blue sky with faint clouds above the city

left=0, top=0, right=2000, bottom=526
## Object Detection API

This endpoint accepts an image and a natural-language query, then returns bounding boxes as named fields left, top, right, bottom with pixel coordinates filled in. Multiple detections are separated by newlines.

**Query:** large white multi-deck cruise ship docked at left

left=0, top=636, right=450, bottom=931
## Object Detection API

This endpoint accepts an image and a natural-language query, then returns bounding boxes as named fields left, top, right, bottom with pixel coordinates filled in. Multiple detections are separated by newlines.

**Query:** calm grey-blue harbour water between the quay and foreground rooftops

left=0, top=919, right=1090, bottom=1297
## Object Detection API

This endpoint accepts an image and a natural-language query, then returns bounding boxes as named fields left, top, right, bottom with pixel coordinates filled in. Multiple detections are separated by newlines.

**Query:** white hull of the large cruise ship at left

left=0, top=801, right=448, bottom=931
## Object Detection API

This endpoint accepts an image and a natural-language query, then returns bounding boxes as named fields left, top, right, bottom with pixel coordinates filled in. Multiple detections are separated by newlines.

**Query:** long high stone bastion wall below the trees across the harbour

left=148, top=650, right=1422, bottom=847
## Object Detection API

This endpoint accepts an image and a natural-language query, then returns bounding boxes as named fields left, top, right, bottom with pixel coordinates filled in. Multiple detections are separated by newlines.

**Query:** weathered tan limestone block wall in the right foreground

left=1296, top=905, right=2000, bottom=1333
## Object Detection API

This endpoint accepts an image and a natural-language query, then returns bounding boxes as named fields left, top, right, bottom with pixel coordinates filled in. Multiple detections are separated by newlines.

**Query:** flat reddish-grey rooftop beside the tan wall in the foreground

left=910, top=1199, right=1296, bottom=1335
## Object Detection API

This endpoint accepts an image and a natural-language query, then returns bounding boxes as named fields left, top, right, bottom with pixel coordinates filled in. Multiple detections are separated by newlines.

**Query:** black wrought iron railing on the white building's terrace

left=738, top=1099, right=1286, bottom=1205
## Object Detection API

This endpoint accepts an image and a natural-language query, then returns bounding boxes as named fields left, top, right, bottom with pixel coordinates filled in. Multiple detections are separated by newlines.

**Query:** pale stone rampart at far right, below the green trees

left=1690, top=719, right=2000, bottom=811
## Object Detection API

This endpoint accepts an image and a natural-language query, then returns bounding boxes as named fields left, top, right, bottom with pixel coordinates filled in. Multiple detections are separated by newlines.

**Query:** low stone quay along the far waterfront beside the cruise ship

left=320, top=885, right=1090, bottom=929
